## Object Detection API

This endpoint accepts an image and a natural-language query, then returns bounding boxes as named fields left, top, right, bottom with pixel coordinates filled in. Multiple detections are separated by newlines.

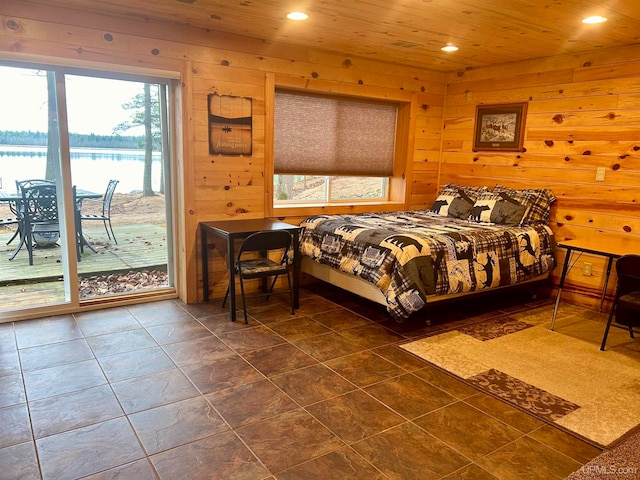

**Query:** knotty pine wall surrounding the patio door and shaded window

left=0, top=0, right=445, bottom=303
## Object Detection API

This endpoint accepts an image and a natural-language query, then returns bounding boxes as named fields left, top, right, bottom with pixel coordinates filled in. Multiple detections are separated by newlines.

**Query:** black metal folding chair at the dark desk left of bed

left=222, top=230, right=295, bottom=323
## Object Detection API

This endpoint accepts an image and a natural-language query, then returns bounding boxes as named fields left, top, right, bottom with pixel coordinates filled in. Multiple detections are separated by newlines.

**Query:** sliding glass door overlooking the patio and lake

left=0, top=65, right=173, bottom=313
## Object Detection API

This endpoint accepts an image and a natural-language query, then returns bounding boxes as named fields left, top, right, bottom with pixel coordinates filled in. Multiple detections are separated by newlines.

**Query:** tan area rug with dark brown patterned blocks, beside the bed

left=401, top=306, right=640, bottom=447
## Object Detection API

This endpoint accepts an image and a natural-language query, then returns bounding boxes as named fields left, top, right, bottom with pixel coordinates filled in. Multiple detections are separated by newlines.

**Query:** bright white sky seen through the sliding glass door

left=0, top=66, right=143, bottom=135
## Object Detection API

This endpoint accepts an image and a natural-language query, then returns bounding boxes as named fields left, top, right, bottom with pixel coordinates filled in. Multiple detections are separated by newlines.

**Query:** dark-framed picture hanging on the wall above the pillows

left=473, top=102, right=528, bottom=152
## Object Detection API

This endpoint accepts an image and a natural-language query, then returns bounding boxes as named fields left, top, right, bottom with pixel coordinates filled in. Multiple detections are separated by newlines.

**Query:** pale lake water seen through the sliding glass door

left=0, top=145, right=162, bottom=193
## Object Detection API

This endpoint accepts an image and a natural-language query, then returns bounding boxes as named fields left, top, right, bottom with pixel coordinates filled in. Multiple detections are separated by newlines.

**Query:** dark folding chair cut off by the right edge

left=600, top=255, right=640, bottom=350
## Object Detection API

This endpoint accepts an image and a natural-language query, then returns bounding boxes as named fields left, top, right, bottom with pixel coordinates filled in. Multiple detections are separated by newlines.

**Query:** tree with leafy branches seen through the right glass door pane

left=113, top=83, right=162, bottom=197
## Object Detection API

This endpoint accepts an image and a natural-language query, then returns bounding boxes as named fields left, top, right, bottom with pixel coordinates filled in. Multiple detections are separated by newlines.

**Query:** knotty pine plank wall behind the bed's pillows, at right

left=440, top=46, right=640, bottom=305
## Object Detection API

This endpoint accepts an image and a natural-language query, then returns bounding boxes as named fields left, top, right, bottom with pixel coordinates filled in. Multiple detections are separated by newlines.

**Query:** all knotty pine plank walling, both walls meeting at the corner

left=0, top=0, right=640, bottom=310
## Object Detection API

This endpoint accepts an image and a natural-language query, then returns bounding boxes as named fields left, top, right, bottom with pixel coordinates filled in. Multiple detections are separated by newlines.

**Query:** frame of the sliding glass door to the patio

left=0, top=56, right=180, bottom=320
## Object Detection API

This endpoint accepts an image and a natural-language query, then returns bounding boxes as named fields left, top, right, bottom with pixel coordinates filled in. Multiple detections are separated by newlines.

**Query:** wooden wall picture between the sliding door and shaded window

left=208, top=94, right=253, bottom=155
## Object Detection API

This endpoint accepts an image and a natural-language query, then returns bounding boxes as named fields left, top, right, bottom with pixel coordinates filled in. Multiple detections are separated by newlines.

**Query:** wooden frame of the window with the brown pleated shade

left=264, top=73, right=417, bottom=217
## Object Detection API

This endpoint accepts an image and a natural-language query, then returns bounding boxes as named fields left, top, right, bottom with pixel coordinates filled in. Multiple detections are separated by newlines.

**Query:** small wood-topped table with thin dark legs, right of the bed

left=551, top=237, right=640, bottom=330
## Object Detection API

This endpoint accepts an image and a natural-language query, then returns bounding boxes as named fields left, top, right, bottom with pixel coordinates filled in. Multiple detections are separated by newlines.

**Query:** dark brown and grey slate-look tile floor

left=0, top=285, right=599, bottom=480
